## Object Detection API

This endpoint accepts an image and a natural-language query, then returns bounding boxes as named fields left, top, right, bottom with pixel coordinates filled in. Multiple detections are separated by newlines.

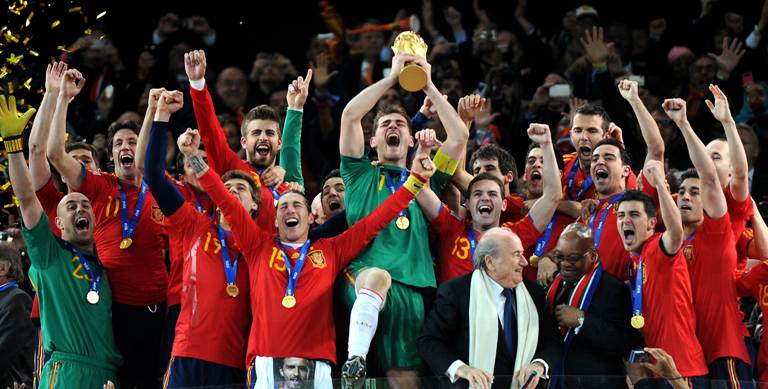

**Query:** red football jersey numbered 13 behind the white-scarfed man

left=429, top=205, right=540, bottom=284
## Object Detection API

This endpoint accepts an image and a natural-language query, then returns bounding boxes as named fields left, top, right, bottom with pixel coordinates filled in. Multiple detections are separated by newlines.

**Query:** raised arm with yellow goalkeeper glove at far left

left=0, top=95, right=43, bottom=229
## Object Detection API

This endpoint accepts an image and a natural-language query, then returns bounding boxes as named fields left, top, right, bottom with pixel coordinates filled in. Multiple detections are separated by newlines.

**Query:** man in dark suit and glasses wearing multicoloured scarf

left=547, top=223, right=641, bottom=388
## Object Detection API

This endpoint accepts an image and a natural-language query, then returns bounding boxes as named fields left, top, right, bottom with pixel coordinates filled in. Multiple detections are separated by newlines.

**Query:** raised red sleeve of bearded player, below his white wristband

left=189, top=84, right=241, bottom=174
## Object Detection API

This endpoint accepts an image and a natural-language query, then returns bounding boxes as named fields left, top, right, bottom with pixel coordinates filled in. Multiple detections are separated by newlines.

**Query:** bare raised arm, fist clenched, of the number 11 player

left=47, top=69, right=85, bottom=190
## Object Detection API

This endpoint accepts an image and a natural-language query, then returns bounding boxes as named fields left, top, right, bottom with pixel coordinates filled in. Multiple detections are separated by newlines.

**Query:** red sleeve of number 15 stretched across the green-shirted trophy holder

left=329, top=186, right=414, bottom=269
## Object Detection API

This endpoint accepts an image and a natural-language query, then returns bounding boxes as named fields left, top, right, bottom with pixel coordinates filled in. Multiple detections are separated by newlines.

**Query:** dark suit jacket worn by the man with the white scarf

left=417, top=274, right=562, bottom=388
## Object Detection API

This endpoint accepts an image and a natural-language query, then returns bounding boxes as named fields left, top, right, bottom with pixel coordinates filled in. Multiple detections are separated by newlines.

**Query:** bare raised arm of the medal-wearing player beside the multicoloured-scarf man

left=643, top=161, right=680, bottom=254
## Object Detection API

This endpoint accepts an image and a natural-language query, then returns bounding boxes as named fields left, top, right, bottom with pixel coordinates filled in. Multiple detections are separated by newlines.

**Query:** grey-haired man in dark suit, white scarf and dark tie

left=417, top=227, right=561, bottom=389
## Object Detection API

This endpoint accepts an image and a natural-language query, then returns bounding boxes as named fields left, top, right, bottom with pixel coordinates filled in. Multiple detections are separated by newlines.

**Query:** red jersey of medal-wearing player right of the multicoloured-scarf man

left=632, top=233, right=704, bottom=377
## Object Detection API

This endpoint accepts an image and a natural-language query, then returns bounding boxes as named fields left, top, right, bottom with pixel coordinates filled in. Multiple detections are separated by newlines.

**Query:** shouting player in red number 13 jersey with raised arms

left=416, top=123, right=562, bottom=284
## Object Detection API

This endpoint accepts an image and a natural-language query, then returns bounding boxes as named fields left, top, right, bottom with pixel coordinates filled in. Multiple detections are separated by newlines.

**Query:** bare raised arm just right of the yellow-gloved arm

left=29, top=62, right=67, bottom=190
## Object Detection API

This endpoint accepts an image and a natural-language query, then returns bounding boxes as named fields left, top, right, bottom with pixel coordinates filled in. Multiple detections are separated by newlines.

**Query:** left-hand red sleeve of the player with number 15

left=199, top=169, right=270, bottom=262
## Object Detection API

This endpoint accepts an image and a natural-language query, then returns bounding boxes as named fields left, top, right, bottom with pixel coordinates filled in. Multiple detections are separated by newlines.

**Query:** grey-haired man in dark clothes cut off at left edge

left=0, top=242, right=35, bottom=388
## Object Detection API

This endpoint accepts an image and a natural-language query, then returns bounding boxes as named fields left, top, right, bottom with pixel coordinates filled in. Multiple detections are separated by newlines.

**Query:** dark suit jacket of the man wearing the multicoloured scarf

left=553, top=272, right=641, bottom=388
